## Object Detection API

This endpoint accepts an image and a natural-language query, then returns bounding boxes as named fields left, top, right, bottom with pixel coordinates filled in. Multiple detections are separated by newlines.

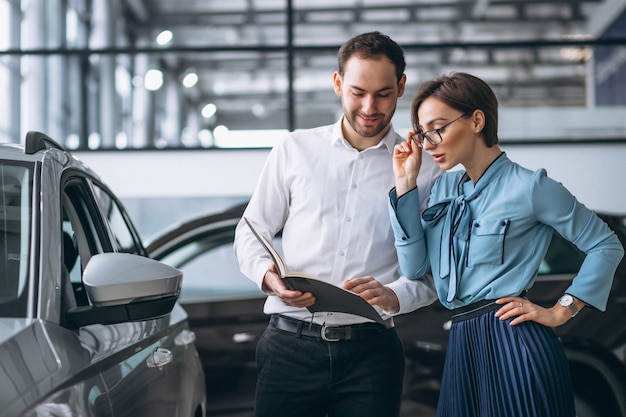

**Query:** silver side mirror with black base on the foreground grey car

left=66, top=252, right=182, bottom=328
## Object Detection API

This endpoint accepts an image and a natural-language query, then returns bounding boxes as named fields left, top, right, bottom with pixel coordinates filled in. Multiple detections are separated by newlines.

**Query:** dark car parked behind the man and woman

left=147, top=205, right=626, bottom=417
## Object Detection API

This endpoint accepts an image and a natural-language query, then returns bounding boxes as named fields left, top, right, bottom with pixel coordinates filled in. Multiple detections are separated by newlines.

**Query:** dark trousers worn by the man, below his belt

left=255, top=327, right=404, bottom=417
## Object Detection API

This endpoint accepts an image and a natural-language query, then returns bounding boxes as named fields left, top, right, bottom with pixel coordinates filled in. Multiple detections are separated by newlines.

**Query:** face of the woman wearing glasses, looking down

left=417, top=97, right=477, bottom=170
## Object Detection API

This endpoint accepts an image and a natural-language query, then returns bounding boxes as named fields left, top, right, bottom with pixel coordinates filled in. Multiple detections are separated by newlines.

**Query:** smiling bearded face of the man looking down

left=334, top=56, right=406, bottom=145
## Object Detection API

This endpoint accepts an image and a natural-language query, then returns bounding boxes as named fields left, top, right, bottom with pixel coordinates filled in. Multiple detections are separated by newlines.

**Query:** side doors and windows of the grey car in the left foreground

left=63, top=175, right=204, bottom=417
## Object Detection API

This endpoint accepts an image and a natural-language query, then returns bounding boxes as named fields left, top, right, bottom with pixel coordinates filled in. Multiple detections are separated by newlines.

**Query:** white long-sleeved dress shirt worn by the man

left=234, top=120, right=441, bottom=325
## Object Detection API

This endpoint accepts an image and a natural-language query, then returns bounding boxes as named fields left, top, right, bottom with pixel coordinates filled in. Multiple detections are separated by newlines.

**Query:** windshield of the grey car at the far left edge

left=0, top=161, right=32, bottom=317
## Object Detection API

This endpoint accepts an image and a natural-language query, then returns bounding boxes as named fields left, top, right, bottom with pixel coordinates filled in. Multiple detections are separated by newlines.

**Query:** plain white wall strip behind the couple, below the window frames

left=75, top=143, right=626, bottom=213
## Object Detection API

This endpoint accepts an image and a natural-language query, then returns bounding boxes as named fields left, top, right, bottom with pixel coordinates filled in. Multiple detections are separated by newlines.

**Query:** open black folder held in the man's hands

left=244, top=217, right=385, bottom=323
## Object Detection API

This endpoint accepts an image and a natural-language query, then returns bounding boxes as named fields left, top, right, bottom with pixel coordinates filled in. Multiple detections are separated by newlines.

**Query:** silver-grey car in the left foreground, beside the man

left=0, top=132, right=206, bottom=417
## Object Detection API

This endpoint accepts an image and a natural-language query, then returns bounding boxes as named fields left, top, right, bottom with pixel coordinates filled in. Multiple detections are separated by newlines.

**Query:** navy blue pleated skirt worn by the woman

left=437, top=302, right=576, bottom=417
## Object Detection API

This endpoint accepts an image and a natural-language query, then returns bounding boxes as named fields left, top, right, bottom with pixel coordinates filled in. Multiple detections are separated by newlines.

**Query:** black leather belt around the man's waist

left=270, top=314, right=393, bottom=342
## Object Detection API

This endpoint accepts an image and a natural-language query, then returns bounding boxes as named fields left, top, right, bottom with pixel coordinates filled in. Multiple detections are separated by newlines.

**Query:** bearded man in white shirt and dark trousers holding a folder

left=235, top=32, right=440, bottom=417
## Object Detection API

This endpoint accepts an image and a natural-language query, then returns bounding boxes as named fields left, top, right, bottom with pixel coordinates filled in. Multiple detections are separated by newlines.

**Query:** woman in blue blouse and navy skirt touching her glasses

left=390, top=73, right=624, bottom=417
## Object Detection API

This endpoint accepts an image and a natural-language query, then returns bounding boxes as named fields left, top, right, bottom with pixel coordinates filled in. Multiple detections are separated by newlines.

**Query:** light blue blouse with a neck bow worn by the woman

left=389, top=152, right=624, bottom=311
